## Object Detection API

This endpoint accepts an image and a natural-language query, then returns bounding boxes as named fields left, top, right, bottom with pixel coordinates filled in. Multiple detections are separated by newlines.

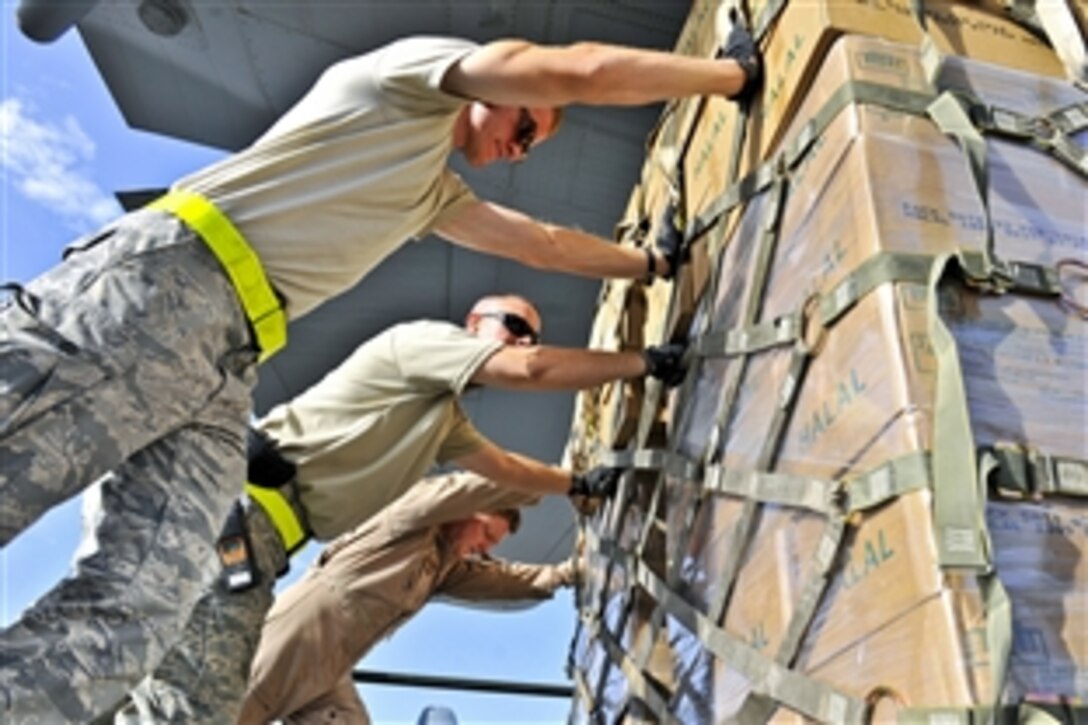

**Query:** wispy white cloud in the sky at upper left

left=0, top=98, right=120, bottom=231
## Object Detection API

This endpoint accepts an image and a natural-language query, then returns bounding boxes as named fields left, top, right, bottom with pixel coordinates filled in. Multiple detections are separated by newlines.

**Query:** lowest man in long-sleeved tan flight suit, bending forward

left=238, top=474, right=574, bottom=725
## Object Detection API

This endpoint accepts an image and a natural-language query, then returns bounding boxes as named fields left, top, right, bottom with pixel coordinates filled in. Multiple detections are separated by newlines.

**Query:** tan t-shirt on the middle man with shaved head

left=259, top=320, right=503, bottom=539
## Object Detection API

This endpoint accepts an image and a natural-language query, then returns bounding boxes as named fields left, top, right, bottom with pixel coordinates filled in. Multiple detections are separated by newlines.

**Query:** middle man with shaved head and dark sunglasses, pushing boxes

left=12, top=295, right=682, bottom=723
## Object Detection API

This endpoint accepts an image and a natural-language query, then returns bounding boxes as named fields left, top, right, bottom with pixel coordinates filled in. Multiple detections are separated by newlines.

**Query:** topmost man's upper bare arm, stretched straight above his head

left=442, top=40, right=745, bottom=107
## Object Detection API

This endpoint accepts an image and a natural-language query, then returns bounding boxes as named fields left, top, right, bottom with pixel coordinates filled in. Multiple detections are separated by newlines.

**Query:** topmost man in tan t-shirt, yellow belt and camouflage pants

left=0, top=26, right=756, bottom=721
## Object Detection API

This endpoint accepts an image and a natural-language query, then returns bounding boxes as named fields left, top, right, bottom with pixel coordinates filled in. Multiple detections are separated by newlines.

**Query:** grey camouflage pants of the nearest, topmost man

left=0, top=211, right=256, bottom=723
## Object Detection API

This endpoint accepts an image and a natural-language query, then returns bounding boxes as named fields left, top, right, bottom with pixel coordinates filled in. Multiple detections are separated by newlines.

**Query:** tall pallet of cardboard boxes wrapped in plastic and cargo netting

left=567, top=0, right=1088, bottom=723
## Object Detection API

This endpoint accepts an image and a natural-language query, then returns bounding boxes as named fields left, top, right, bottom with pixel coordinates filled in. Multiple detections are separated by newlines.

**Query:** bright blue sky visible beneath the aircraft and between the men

left=0, top=11, right=574, bottom=724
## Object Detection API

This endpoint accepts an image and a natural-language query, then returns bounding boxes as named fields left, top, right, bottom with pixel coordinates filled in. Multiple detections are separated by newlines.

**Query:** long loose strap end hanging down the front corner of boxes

left=926, top=256, right=990, bottom=574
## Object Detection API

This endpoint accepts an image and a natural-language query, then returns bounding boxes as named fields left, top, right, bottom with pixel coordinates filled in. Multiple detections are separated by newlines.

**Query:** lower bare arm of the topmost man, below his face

left=434, top=201, right=668, bottom=279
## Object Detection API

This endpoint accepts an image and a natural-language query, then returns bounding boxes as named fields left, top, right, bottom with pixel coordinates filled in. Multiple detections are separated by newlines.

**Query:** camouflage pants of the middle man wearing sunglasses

left=114, top=500, right=286, bottom=725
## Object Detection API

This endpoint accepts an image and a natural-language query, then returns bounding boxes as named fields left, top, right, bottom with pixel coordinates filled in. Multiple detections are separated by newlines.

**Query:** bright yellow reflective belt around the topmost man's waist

left=148, top=191, right=287, bottom=361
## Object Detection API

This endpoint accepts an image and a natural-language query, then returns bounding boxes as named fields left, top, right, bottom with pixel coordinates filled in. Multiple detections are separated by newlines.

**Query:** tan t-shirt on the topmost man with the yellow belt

left=174, top=37, right=477, bottom=319
